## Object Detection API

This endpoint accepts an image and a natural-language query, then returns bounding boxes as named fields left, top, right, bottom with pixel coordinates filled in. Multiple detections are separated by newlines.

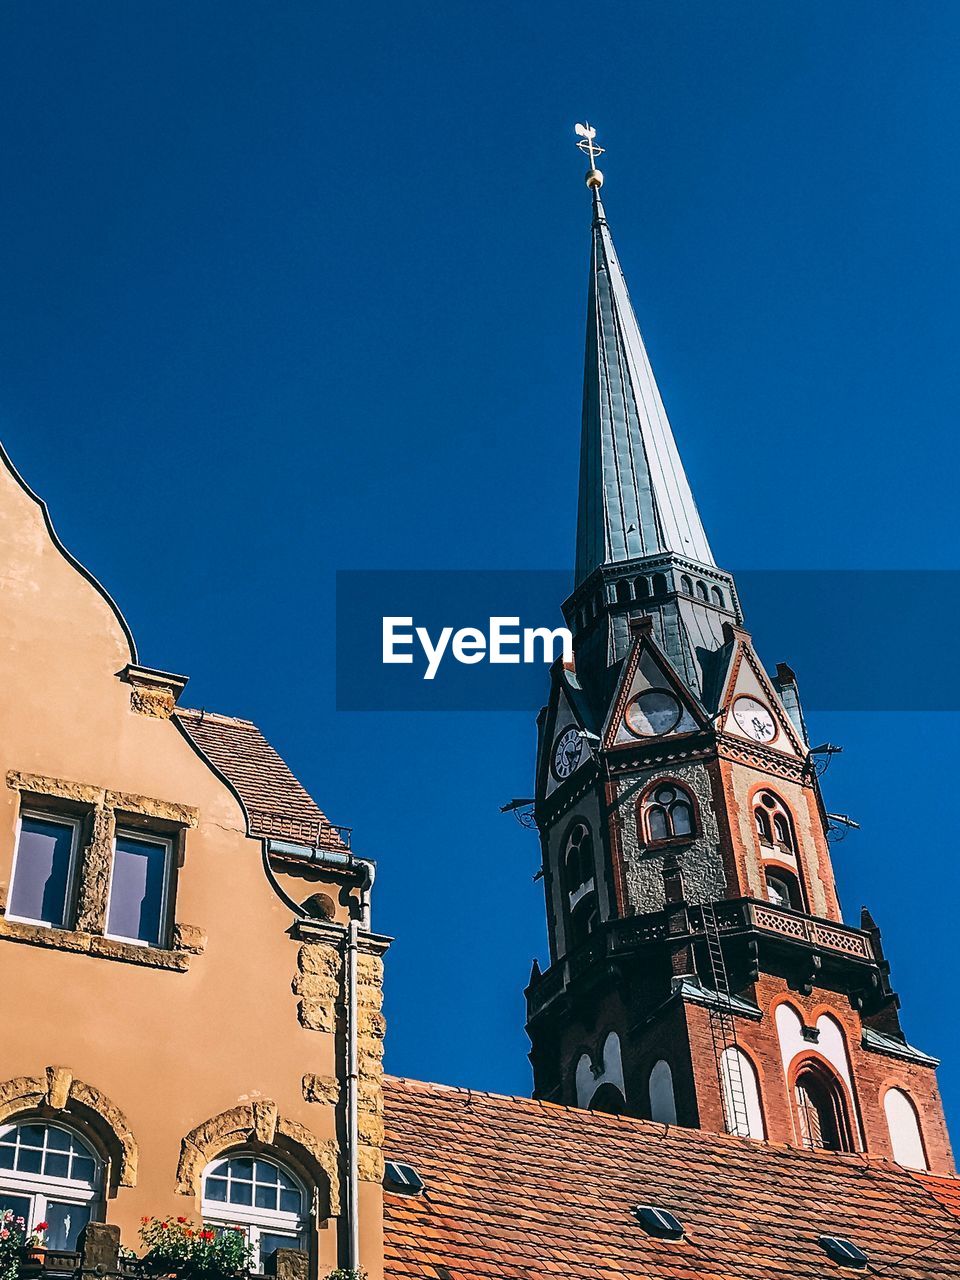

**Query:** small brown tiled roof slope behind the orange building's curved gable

left=177, top=708, right=344, bottom=850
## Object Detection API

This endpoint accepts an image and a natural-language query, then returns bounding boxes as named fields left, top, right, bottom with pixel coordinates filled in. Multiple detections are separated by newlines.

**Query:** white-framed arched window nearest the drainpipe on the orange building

left=201, top=1155, right=307, bottom=1271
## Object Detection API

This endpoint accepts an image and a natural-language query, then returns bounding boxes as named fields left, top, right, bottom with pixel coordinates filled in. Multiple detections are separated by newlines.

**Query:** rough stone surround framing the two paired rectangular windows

left=0, top=769, right=206, bottom=973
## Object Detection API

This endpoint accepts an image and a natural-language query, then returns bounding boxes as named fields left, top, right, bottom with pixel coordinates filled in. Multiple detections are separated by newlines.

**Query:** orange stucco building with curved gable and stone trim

left=0, top=437, right=387, bottom=1277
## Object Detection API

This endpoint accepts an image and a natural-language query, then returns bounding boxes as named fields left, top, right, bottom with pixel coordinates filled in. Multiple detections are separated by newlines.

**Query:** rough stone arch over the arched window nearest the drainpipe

left=177, top=1098, right=340, bottom=1217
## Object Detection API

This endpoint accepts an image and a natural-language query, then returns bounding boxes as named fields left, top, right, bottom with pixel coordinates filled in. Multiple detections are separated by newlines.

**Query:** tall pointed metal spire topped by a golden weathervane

left=576, top=124, right=714, bottom=586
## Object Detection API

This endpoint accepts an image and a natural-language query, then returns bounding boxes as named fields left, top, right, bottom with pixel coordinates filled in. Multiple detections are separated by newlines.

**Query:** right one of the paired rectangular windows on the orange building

left=106, top=831, right=173, bottom=947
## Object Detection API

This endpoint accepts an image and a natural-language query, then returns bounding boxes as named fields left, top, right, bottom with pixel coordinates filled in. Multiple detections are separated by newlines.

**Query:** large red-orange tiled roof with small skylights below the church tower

left=384, top=1078, right=960, bottom=1280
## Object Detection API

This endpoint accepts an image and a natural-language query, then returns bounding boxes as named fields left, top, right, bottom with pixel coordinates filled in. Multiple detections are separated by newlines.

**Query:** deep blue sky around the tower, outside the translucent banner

left=0, top=0, right=960, bottom=1117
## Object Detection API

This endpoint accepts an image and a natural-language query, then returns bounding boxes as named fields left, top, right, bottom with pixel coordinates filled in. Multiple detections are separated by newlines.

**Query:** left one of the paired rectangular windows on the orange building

left=6, top=809, right=79, bottom=929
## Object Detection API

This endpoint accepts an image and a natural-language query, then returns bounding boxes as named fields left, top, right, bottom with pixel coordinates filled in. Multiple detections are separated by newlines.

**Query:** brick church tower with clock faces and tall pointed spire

left=526, top=125, right=952, bottom=1171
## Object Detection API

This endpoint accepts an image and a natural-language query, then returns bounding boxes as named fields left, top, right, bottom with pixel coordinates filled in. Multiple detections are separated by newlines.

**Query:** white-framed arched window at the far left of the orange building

left=0, top=1120, right=102, bottom=1249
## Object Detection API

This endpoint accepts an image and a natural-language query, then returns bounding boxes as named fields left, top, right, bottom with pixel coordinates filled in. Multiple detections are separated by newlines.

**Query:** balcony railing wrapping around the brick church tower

left=527, top=897, right=882, bottom=1018
